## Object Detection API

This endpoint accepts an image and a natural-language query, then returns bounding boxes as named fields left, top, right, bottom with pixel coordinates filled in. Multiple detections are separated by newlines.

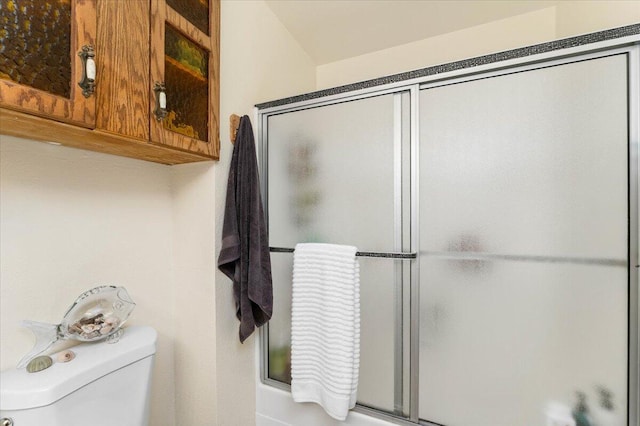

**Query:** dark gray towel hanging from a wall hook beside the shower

left=218, top=115, right=273, bottom=342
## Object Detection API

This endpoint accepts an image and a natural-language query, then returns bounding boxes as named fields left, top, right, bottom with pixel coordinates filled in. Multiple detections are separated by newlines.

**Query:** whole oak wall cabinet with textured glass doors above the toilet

left=0, top=0, right=220, bottom=164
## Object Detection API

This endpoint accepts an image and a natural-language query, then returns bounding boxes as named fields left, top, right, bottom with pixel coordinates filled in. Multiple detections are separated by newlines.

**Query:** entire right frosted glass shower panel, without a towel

left=419, top=55, right=629, bottom=426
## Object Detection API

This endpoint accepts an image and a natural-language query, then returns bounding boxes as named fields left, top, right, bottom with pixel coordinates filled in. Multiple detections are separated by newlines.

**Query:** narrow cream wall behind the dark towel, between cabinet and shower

left=215, top=0, right=315, bottom=426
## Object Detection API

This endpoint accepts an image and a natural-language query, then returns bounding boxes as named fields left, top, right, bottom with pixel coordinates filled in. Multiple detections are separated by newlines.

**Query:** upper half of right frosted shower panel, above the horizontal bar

left=420, top=55, right=628, bottom=261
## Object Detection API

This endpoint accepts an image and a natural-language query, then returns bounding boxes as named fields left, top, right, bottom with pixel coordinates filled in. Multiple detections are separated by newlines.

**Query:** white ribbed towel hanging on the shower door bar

left=291, top=243, right=360, bottom=420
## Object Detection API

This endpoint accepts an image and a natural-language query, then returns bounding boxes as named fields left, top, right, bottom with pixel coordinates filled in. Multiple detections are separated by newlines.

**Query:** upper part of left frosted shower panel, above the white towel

left=268, top=95, right=394, bottom=251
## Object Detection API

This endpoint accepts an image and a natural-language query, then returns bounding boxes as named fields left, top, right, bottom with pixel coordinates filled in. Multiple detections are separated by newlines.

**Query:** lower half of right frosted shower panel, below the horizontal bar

left=420, top=258, right=627, bottom=426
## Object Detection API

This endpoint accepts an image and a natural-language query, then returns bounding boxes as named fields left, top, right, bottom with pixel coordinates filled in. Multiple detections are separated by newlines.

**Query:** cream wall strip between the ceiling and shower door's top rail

left=316, top=0, right=640, bottom=89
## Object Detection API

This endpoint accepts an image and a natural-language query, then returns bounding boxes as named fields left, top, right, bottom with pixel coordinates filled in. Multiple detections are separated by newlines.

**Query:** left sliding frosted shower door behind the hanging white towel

left=266, top=93, right=409, bottom=412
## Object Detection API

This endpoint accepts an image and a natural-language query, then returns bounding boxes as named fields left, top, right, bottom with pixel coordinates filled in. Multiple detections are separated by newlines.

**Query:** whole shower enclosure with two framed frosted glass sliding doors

left=257, top=29, right=640, bottom=426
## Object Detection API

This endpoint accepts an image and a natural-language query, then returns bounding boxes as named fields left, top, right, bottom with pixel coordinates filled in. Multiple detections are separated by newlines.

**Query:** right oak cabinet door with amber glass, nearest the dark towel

left=150, top=0, right=220, bottom=159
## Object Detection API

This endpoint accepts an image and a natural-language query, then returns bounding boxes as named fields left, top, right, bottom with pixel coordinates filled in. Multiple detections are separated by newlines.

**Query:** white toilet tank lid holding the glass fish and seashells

left=0, top=326, right=158, bottom=410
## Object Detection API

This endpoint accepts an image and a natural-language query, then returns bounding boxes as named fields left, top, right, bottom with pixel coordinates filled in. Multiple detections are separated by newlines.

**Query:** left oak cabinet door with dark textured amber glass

left=0, top=0, right=98, bottom=128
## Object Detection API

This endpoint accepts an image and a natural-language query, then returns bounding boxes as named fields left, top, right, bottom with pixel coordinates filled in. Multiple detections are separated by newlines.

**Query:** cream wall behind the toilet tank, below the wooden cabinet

left=0, top=136, right=176, bottom=426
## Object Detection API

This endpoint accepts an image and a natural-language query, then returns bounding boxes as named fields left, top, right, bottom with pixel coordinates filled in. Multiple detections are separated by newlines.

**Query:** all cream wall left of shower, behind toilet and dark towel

left=0, top=0, right=315, bottom=426
